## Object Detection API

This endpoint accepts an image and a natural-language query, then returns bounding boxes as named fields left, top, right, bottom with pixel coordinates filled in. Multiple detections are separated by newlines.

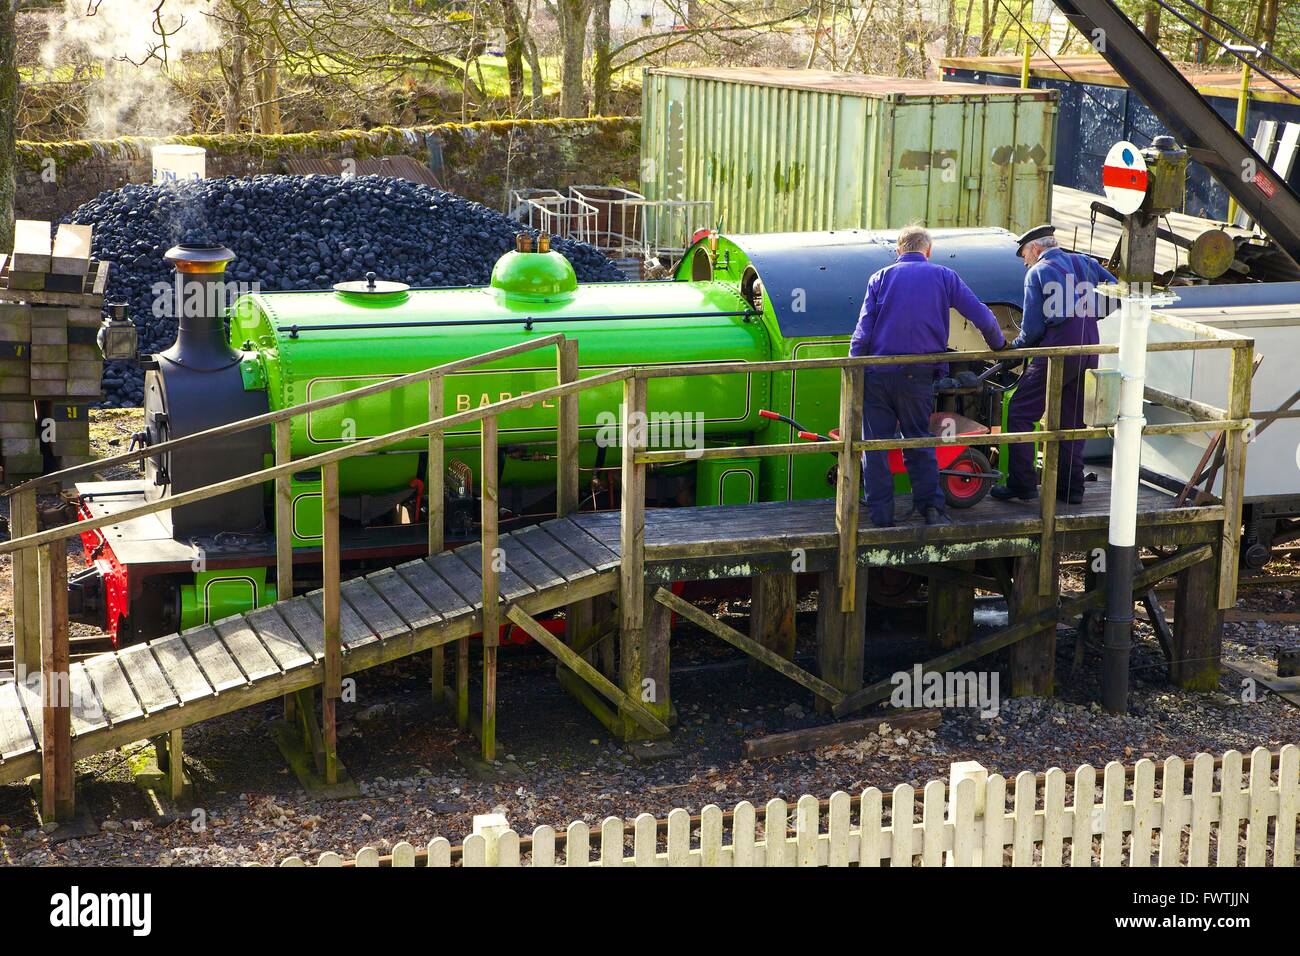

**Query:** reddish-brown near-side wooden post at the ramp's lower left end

left=38, top=541, right=75, bottom=822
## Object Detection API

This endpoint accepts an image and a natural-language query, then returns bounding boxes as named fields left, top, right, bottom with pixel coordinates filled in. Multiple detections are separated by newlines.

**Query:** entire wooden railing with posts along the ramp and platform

left=0, top=316, right=1253, bottom=814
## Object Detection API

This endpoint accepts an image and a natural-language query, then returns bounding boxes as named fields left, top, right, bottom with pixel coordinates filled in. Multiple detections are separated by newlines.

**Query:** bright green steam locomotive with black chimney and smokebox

left=69, top=229, right=1023, bottom=641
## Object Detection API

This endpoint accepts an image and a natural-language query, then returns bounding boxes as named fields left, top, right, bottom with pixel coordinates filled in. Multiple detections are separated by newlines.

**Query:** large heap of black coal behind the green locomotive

left=66, top=176, right=624, bottom=406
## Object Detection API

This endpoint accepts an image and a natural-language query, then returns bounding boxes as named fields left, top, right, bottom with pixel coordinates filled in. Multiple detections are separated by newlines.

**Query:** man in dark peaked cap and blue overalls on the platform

left=992, top=225, right=1117, bottom=505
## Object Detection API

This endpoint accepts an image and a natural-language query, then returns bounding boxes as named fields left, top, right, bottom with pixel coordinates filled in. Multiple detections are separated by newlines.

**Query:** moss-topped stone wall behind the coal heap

left=16, top=117, right=641, bottom=221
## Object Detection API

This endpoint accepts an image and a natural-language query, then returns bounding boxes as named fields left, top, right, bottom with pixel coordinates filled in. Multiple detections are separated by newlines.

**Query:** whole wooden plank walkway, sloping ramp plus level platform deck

left=0, top=475, right=1222, bottom=783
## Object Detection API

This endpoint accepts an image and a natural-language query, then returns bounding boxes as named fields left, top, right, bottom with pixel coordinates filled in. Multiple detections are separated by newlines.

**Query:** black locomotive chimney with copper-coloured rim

left=163, top=242, right=239, bottom=372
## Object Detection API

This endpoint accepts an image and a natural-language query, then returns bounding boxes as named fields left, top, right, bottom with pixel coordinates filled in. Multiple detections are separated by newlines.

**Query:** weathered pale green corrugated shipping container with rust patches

left=641, top=69, right=1057, bottom=233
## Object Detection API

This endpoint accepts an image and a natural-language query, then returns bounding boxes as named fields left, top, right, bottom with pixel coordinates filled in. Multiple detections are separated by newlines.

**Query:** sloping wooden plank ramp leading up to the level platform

left=0, top=518, right=619, bottom=784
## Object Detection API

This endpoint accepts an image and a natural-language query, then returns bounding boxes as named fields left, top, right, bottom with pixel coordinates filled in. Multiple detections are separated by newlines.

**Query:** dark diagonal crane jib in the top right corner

left=1053, top=0, right=1300, bottom=268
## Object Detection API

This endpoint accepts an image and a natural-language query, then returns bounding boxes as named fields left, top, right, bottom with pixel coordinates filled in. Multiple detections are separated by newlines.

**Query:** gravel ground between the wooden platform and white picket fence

left=0, top=568, right=1297, bottom=865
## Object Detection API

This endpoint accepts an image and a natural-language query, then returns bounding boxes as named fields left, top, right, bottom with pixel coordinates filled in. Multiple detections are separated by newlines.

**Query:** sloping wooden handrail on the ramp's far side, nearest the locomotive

left=0, top=333, right=564, bottom=494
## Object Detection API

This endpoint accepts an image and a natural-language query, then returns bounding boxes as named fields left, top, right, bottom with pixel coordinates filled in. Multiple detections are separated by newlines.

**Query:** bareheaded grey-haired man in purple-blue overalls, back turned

left=849, top=226, right=1006, bottom=528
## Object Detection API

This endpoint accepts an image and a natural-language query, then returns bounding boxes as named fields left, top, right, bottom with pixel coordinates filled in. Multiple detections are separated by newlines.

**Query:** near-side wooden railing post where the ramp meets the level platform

left=619, top=375, right=646, bottom=700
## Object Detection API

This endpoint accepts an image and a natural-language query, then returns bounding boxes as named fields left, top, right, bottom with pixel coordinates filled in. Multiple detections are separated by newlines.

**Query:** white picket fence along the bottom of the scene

left=281, top=745, right=1300, bottom=866
